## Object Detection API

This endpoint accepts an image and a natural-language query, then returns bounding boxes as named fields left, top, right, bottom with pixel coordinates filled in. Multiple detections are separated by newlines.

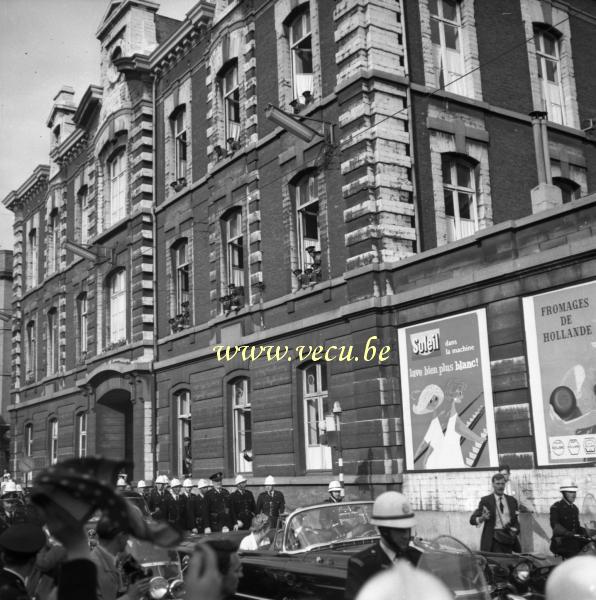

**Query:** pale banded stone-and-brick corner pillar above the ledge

left=334, top=0, right=416, bottom=270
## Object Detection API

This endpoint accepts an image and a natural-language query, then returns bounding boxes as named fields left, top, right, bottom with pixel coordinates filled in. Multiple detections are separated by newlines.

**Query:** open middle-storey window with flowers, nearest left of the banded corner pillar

left=295, top=174, right=321, bottom=270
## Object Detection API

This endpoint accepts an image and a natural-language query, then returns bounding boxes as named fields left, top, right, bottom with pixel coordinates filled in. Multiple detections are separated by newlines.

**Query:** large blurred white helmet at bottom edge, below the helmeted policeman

left=356, top=560, right=453, bottom=600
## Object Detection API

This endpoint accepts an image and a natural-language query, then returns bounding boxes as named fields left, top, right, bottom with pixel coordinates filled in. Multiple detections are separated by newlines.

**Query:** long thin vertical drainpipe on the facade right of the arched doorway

left=151, top=75, right=157, bottom=479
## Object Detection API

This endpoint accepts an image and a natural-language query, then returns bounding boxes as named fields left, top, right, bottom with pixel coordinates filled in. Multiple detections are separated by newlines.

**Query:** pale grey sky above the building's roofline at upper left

left=0, top=0, right=196, bottom=249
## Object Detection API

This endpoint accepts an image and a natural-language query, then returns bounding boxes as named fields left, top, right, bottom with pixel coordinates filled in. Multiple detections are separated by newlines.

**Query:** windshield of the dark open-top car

left=284, top=502, right=378, bottom=551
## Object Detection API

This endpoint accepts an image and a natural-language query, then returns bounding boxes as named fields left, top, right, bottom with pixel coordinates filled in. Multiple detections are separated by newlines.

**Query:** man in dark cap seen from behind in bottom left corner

left=0, top=523, right=46, bottom=600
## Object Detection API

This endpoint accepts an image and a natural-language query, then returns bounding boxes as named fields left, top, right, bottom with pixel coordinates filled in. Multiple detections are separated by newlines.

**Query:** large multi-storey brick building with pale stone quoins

left=5, top=0, right=596, bottom=546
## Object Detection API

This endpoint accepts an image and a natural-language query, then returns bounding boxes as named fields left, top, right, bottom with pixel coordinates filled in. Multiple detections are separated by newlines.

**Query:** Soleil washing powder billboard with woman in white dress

left=398, top=310, right=498, bottom=470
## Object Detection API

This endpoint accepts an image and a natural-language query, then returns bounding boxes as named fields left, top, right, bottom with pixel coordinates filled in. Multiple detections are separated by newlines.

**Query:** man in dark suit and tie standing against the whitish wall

left=470, top=473, right=521, bottom=554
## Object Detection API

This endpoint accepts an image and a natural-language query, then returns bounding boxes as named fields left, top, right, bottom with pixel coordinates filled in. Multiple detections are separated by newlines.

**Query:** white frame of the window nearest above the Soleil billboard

left=441, top=153, right=479, bottom=243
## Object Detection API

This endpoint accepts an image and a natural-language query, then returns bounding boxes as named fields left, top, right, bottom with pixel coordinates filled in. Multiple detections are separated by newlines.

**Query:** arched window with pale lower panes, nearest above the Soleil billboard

left=443, top=156, right=478, bottom=242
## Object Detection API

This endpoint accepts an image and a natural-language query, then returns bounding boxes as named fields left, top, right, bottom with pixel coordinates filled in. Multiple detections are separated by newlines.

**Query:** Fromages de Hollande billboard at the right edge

left=523, top=282, right=596, bottom=465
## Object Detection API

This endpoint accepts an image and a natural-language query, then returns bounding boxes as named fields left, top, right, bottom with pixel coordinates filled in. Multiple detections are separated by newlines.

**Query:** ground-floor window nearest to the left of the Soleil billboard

left=302, top=363, right=332, bottom=470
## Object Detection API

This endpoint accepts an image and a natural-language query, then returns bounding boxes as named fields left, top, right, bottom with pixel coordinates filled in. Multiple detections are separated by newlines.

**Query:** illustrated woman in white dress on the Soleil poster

left=412, top=382, right=485, bottom=469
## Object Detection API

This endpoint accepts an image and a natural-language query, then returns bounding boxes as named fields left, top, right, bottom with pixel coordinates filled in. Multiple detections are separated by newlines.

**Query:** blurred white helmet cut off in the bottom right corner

left=546, top=556, right=596, bottom=600
